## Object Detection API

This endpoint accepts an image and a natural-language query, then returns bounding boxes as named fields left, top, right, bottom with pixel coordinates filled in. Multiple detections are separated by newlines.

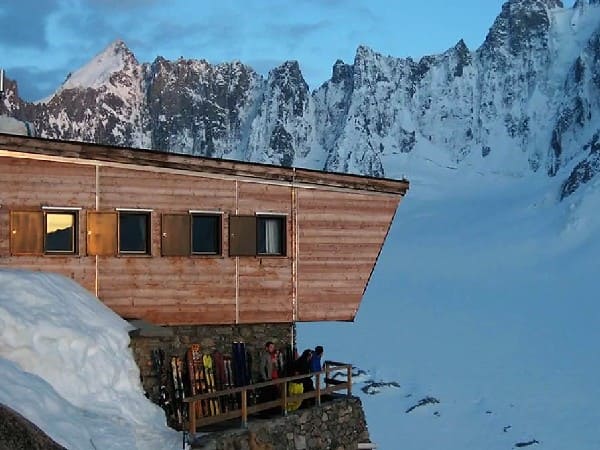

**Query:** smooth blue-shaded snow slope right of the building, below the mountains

left=298, top=166, right=600, bottom=450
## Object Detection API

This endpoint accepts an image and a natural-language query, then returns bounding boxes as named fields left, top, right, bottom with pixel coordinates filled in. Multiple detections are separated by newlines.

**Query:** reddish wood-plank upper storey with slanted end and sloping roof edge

left=0, top=134, right=408, bottom=325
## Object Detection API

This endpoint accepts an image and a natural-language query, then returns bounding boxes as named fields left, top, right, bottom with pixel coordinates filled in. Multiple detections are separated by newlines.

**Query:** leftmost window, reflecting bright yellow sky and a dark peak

left=44, top=211, right=77, bottom=254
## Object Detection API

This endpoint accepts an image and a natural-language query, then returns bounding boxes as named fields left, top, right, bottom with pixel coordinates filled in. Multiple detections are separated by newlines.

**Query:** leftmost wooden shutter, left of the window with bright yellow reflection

left=10, top=211, right=44, bottom=255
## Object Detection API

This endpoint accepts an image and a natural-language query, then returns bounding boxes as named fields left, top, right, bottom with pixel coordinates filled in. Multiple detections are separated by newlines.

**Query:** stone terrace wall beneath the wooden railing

left=192, top=397, right=370, bottom=450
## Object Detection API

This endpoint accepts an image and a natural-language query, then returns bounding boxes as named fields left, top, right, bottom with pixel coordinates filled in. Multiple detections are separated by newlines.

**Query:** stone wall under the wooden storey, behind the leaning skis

left=130, top=323, right=296, bottom=402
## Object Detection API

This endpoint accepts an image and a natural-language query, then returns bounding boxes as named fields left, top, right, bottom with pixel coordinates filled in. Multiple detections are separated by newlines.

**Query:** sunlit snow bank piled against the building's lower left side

left=0, top=269, right=181, bottom=450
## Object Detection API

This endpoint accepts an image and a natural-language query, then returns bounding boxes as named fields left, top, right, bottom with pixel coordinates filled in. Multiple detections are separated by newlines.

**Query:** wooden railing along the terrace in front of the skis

left=184, top=361, right=352, bottom=435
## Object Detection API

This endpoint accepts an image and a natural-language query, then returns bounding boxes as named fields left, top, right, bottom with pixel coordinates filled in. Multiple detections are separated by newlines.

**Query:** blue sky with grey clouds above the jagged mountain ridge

left=0, top=0, right=504, bottom=101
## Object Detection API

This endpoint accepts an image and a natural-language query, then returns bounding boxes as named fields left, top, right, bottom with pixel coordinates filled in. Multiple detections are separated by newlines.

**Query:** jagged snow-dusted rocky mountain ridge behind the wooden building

left=0, top=0, right=600, bottom=197
